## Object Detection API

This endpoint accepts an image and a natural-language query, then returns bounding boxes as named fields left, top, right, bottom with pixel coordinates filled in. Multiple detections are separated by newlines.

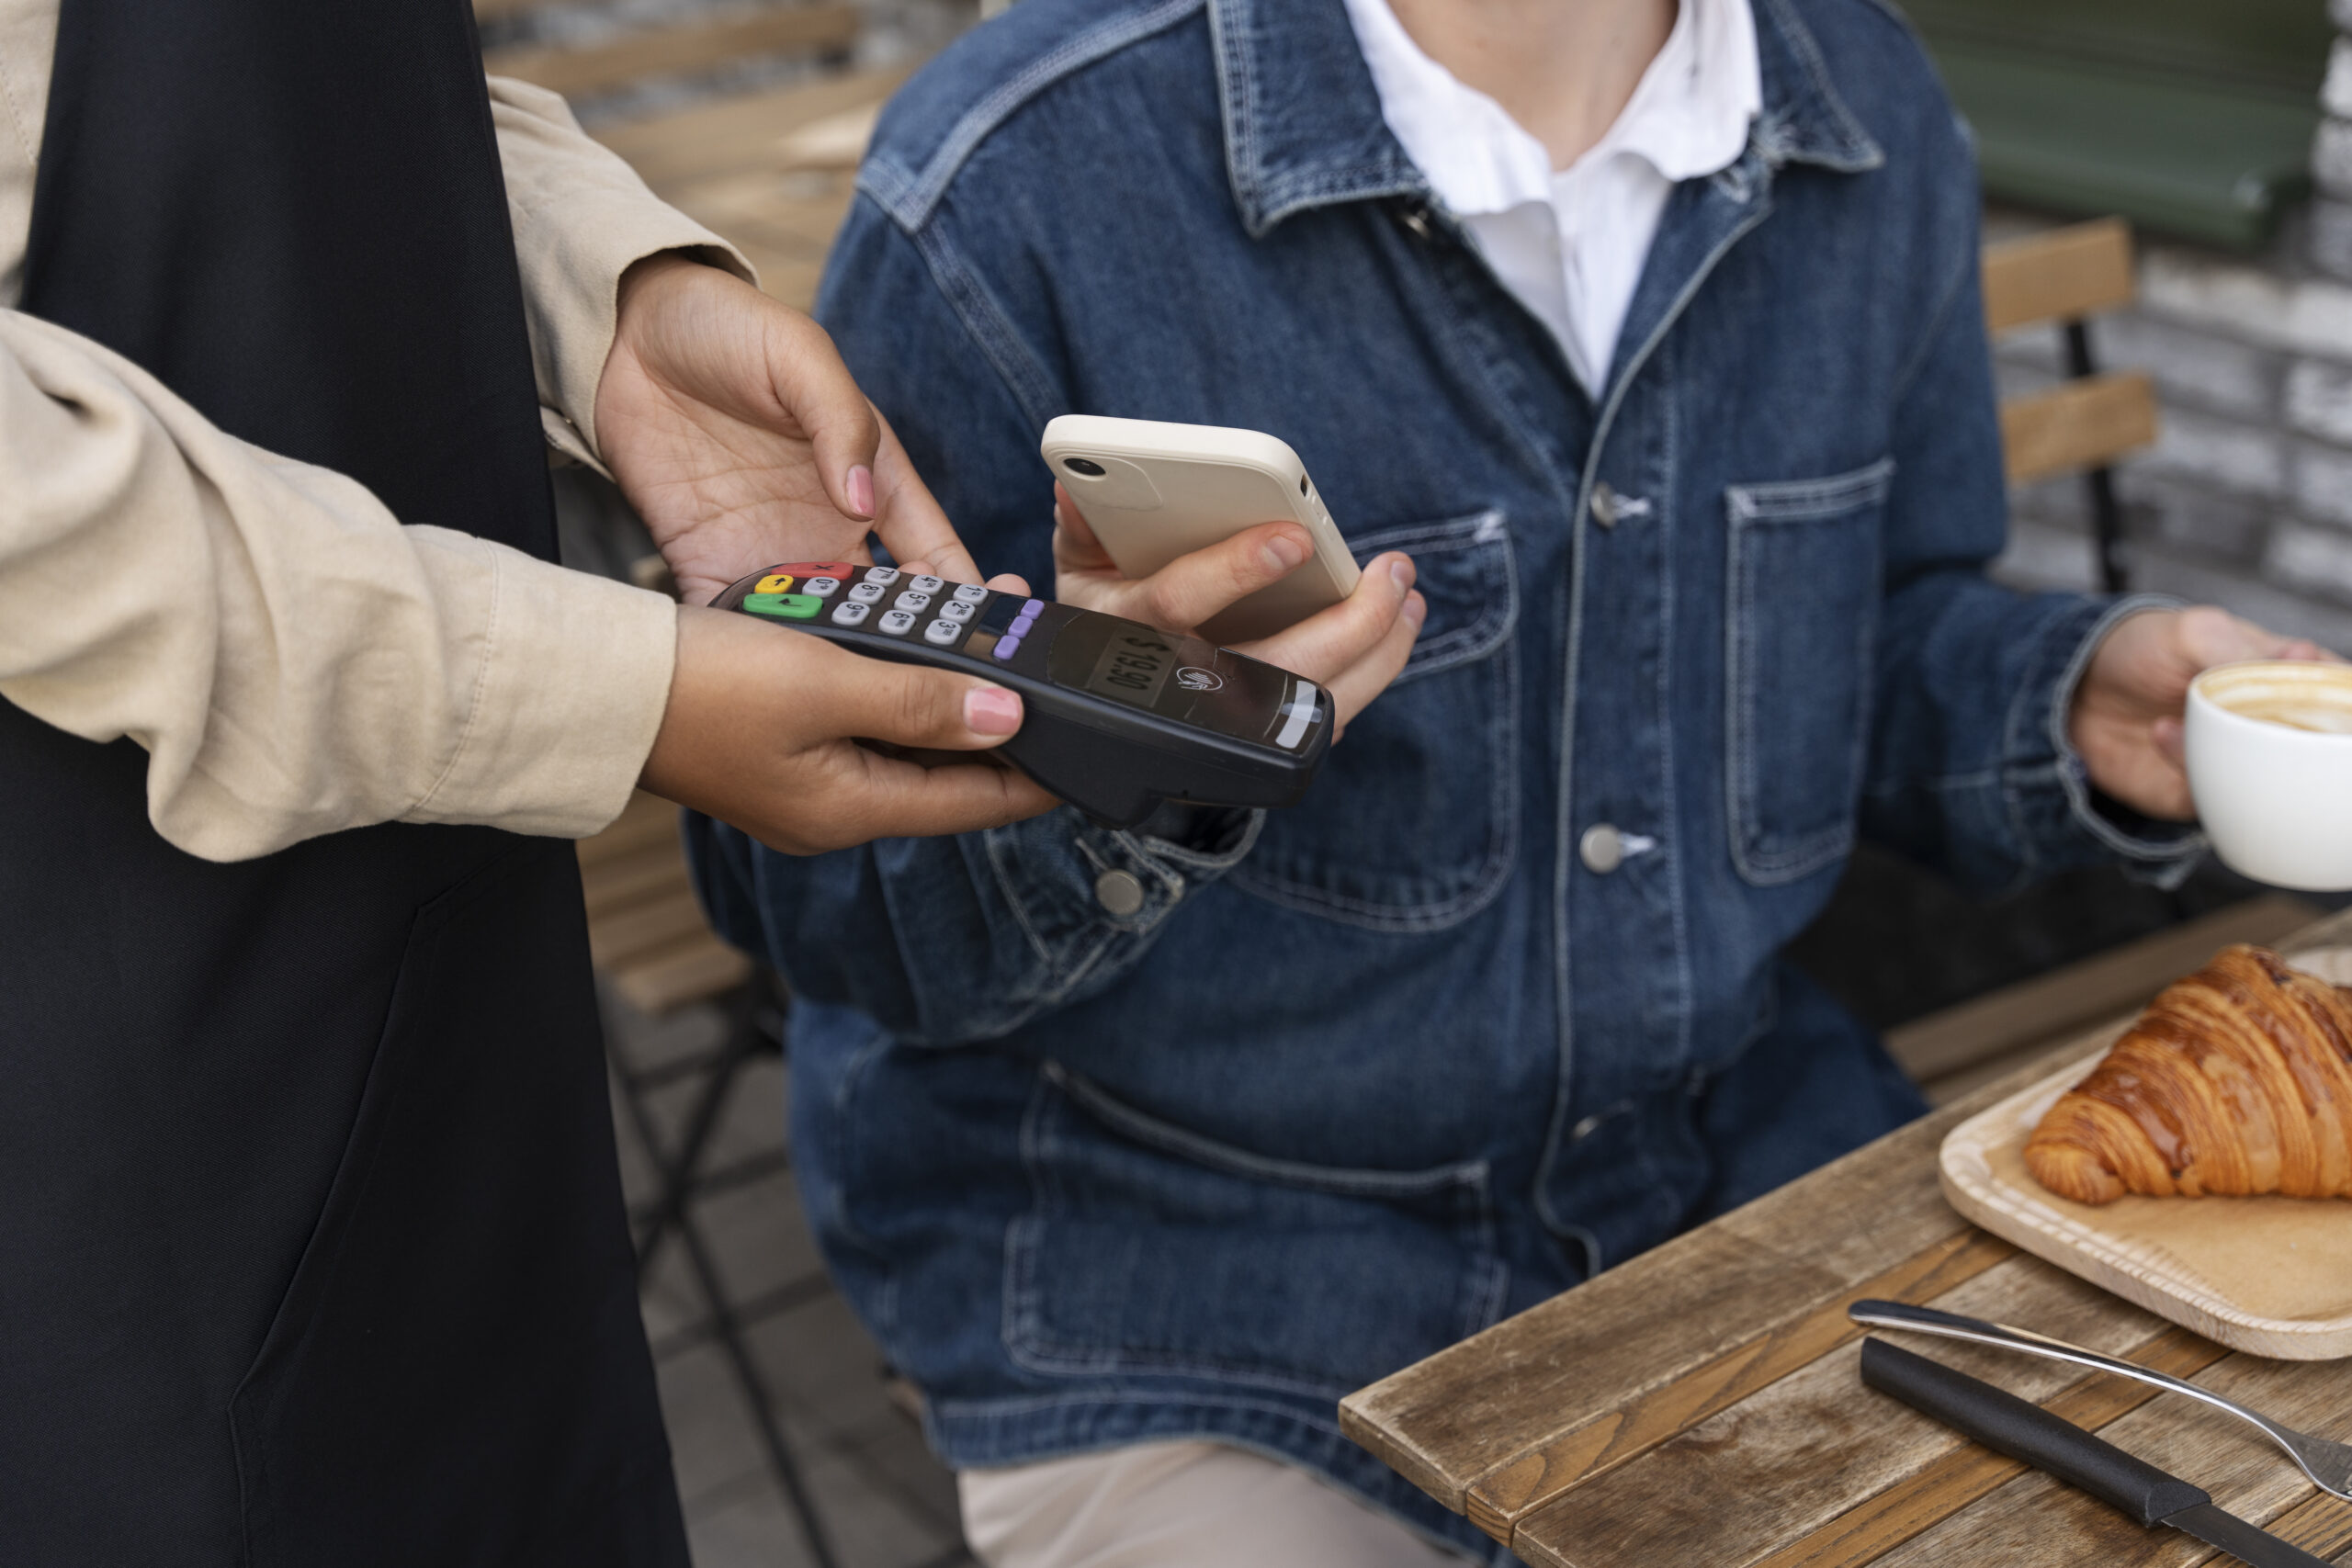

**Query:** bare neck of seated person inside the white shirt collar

left=1390, top=0, right=1687, bottom=169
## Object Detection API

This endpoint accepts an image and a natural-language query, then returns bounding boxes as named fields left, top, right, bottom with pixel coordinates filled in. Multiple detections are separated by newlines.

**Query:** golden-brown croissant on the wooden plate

left=2025, top=945, right=2352, bottom=1203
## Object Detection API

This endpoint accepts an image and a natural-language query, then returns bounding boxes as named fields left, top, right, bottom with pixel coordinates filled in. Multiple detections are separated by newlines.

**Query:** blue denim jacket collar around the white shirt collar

left=1209, top=0, right=1884, bottom=237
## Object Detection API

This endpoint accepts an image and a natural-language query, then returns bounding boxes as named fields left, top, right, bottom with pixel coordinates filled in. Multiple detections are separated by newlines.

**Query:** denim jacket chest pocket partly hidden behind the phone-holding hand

left=1227, top=510, right=1520, bottom=931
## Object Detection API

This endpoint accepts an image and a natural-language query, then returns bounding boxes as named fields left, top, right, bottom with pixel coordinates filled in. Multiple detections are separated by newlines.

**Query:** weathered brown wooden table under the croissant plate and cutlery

left=1340, top=915, right=2352, bottom=1568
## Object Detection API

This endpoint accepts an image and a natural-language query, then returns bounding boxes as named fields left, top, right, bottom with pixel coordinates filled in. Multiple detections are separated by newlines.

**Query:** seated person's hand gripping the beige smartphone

left=1054, top=484, right=1428, bottom=731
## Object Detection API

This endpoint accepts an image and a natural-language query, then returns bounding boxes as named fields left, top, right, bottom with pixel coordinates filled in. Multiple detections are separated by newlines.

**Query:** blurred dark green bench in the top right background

left=1903, top=0, right=2335, bottom=249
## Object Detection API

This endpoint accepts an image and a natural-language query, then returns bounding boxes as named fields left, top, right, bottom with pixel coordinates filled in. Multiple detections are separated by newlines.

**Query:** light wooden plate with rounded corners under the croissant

left=1940, top=947, right=2352, bottom=1361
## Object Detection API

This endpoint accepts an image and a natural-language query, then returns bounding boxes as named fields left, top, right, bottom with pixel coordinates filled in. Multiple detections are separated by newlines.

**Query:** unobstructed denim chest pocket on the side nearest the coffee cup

left=1724, top=458, right=1895, bottom=886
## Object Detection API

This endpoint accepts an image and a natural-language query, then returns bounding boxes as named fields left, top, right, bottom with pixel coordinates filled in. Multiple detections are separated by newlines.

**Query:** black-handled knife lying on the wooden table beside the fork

left=1863, top=1340, right=2328, bottom=1568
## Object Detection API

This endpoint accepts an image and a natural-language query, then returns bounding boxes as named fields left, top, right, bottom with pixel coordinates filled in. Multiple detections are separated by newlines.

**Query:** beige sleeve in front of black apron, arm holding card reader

left=0, top=310, right=677, bottom=861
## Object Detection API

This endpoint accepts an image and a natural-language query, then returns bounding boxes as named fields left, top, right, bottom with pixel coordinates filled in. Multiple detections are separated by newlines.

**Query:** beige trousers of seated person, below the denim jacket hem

left=955, top=1441, right=1470, bottom=1568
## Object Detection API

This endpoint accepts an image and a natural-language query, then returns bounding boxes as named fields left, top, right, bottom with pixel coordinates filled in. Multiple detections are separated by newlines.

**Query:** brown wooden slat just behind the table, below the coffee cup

left=1886, top=894, right=2322, bottom=1084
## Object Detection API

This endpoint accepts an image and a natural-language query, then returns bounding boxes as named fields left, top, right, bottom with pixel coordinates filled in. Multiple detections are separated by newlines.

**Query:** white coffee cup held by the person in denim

left=2185, top=660, right=2352, bottom=891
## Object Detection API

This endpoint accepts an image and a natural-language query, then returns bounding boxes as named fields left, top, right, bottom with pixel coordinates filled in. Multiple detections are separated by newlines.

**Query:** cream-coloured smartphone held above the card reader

left=1037, top=413, right=1360, bottom=644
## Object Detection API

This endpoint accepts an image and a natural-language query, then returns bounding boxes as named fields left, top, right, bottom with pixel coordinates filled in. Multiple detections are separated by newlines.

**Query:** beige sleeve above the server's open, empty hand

left=489, top=75, right=760, bottom=472
